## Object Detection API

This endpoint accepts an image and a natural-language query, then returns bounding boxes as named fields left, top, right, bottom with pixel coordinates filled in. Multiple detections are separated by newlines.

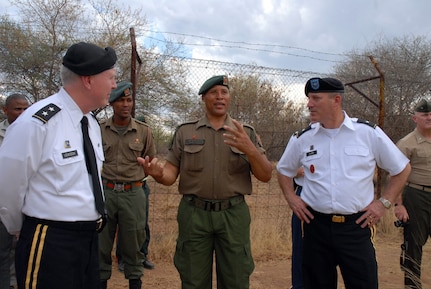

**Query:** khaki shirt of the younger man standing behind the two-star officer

left=100, top=117, right=156, bottom=182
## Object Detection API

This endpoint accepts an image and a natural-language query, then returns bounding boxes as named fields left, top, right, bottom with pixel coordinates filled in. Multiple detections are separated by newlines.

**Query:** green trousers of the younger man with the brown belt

left=99, top=186, right=146, bottom=281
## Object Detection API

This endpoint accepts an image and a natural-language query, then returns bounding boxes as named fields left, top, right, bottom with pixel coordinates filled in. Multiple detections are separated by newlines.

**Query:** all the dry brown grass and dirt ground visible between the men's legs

left=108, top=165, right=431, bottom=289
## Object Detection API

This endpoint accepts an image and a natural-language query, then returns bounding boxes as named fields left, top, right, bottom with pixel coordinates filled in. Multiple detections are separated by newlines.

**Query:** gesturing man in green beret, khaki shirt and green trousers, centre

left=138, top=75, right=272, bottom=289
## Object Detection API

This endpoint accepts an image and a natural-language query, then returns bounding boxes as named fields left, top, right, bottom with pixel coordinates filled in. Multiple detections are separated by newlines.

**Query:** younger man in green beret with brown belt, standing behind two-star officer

left=99, top=82, right=156, bottom=289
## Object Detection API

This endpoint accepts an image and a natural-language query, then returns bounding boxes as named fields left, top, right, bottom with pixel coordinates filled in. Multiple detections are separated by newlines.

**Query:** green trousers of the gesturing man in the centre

left=174, top=198, right=254, bottom=289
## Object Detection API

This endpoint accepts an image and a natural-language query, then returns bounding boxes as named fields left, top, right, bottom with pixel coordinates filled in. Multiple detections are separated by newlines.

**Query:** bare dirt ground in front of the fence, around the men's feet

left=108, top=237, right=431, bottom=289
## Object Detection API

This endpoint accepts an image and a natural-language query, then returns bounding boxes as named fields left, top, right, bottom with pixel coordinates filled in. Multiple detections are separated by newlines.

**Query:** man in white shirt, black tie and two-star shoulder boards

left=0, top=42, right=117, bottom=289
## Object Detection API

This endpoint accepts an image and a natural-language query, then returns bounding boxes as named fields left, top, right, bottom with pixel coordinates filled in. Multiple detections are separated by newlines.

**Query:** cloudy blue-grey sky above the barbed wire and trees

left=0, top=0, right=431, bottom=74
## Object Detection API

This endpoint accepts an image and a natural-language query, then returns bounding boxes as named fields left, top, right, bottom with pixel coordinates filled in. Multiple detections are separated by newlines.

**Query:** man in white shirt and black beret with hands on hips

left=277, top=77, right=410, bottom=289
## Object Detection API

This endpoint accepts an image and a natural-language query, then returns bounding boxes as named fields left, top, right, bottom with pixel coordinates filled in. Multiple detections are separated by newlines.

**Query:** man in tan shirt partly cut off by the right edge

left=394, top=98, right=431, bottom=288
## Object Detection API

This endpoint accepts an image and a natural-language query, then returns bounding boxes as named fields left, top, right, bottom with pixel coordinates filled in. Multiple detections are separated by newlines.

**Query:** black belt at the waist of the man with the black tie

left=25, top=216, right=107, bottom=233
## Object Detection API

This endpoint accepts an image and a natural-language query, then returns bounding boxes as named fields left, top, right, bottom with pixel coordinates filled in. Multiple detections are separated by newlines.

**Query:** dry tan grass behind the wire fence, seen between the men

left=149, top=166, right=401, bottom=261
